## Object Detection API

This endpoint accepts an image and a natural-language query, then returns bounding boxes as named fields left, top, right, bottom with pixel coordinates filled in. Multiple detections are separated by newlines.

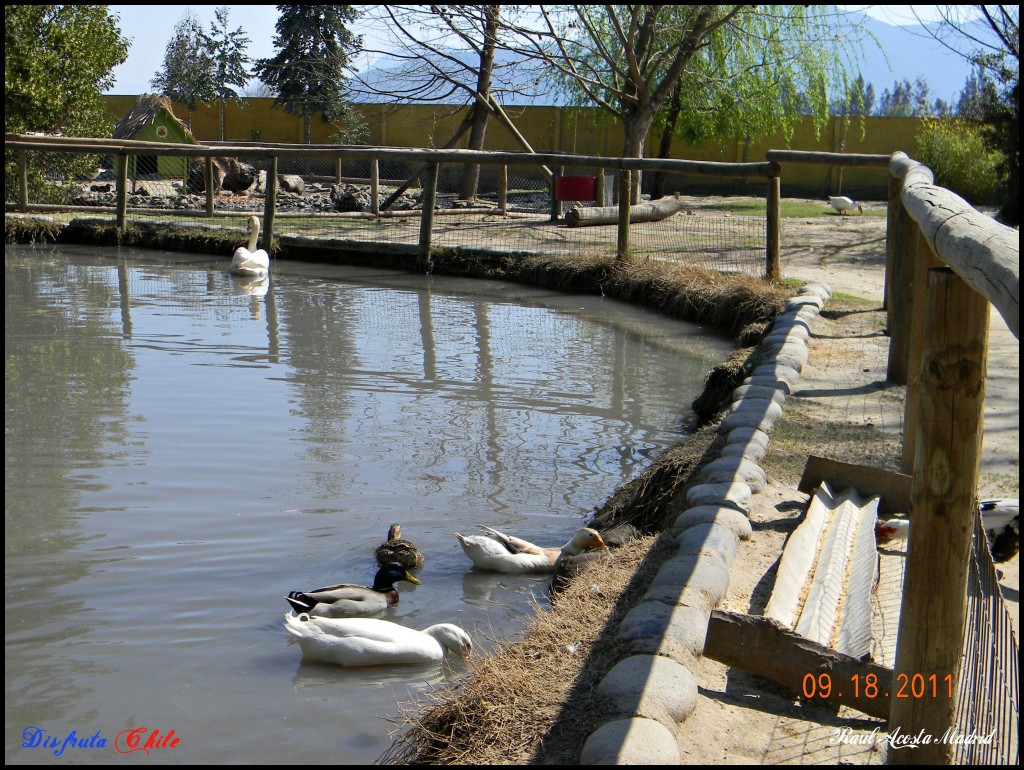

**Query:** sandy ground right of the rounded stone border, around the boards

left=679, top=205, right=1020, bottom=764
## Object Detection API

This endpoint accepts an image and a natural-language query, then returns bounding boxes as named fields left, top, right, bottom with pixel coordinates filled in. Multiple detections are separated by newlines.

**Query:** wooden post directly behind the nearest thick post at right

left=901, top=231, right=942, bottom=474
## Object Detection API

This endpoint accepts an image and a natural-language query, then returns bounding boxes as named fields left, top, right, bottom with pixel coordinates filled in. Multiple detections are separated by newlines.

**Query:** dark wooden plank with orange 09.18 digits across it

left=703, top=610, right=893, bottom=719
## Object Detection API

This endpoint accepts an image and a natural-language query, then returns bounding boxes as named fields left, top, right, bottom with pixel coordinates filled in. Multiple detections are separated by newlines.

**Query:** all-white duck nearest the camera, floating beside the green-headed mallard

left=285, top=612, right=473, bottom=666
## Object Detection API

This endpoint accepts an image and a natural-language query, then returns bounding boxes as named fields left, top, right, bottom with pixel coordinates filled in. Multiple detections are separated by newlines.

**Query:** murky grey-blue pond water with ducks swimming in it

left=4, top=241, right=732, bottom=764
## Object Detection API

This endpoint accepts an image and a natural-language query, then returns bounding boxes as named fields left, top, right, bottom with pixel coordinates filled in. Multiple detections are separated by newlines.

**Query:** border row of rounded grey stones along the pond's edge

left=580, top=284, right=831, bottom=765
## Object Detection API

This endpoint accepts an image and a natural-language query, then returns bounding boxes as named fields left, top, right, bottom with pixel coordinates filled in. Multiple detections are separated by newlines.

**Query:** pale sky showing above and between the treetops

left=108, top=5, right=978, bottom=100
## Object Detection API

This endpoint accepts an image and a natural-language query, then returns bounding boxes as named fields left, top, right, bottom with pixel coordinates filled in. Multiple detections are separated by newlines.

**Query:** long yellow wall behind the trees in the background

left=105, top=96, right=921, bottom=198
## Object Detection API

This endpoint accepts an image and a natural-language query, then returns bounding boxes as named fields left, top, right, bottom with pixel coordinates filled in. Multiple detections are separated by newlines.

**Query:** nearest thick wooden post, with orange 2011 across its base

left=889, top=267, right=989, bottom=765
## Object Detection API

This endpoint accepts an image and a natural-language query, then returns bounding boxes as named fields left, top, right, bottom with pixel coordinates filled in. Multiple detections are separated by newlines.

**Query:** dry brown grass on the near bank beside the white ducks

left=379, top=536, right=672, bottom=765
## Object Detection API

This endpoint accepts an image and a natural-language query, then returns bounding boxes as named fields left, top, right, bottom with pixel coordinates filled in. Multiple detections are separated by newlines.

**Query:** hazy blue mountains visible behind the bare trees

left=353, top=12, right=971, bottom=106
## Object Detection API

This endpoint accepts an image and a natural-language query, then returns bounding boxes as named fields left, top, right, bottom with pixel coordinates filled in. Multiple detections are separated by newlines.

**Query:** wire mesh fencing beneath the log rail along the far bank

left=5, top=137, right=770, bottom=275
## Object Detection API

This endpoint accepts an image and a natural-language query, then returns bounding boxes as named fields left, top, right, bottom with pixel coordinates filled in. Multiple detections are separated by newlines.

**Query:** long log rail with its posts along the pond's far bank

left=4, top=134, right=781, bottom=281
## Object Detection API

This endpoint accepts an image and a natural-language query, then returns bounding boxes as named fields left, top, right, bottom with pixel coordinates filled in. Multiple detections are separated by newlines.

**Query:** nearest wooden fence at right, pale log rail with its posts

left=887, top=153, right=1020, bottom=764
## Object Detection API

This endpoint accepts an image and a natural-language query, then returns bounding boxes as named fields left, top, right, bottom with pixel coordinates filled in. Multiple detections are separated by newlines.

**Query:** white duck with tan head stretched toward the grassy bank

left=455, top=526, right=607, bottom=574
